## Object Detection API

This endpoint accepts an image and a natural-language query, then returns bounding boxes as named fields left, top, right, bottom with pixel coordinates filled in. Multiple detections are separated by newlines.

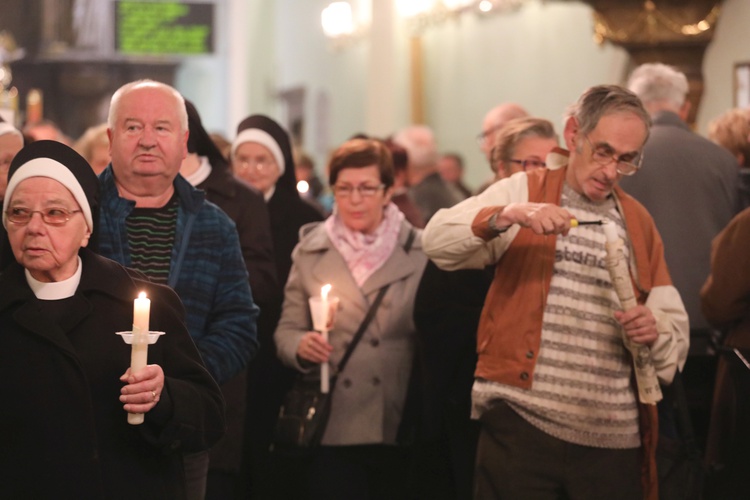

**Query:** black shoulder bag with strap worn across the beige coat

left=272, top=230, right=416, bottom=449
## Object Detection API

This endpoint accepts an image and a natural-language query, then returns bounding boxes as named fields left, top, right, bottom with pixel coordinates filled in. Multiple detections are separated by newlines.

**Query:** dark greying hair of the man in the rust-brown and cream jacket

left=566, top=85, right=651, bottom=138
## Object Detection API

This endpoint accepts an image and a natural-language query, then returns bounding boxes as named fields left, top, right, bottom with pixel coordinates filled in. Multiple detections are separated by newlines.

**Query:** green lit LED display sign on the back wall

left=115, top=0, right=214, bottom=55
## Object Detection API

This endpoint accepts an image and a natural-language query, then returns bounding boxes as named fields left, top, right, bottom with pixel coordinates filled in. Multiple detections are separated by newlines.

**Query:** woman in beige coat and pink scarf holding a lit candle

left=274, top=139, right=427, bottom=498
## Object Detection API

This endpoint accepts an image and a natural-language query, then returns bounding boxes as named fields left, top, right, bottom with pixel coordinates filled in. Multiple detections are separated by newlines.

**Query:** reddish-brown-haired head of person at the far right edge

left=708, top=108, right=750, bottom=208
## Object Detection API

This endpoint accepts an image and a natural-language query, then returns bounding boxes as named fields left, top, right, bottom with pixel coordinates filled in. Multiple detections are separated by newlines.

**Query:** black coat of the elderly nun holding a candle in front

left=0, top=249, right=224, bottom=499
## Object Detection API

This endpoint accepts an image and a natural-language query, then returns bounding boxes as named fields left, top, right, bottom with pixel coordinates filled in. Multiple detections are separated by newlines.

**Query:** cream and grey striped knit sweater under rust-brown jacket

left=474, top=185, right=640, bottom=448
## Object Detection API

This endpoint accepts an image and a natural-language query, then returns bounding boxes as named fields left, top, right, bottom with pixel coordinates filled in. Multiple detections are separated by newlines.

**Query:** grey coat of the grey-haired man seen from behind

left=620, top=111, right=740, bottom=336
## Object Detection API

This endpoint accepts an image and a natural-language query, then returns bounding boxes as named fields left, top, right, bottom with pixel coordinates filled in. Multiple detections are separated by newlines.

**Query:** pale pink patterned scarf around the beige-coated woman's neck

left=325, top=203, right=404, bottom=287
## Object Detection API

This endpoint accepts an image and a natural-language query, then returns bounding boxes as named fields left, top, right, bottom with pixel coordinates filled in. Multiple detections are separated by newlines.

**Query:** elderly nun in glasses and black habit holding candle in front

left=0, top=141, right=225, bottom=498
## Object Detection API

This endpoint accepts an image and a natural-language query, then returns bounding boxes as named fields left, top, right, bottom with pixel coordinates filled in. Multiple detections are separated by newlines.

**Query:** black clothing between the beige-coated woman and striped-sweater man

left=408, top=261, right=495, bottom=499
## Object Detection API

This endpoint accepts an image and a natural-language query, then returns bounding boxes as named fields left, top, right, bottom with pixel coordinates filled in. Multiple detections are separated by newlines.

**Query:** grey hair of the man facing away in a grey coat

left=628, top=63, right=688, bottom=109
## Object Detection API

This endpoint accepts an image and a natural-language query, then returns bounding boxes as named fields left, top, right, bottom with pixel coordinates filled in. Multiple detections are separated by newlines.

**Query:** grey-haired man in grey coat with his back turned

left=620, top=63, right=740, bottom=449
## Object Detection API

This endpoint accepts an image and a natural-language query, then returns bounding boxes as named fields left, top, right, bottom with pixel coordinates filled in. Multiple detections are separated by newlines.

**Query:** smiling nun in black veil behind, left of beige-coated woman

left=231, top=115, right=323, bottom=499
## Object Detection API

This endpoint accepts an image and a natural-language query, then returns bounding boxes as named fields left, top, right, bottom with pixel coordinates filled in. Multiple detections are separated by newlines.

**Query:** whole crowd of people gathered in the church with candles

left=0, top=63, right=750, bottom=500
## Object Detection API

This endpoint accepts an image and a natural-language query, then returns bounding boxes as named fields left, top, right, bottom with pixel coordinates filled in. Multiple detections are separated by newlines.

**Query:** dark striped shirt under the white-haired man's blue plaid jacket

left=126, top=197, right=177, bottom=283
